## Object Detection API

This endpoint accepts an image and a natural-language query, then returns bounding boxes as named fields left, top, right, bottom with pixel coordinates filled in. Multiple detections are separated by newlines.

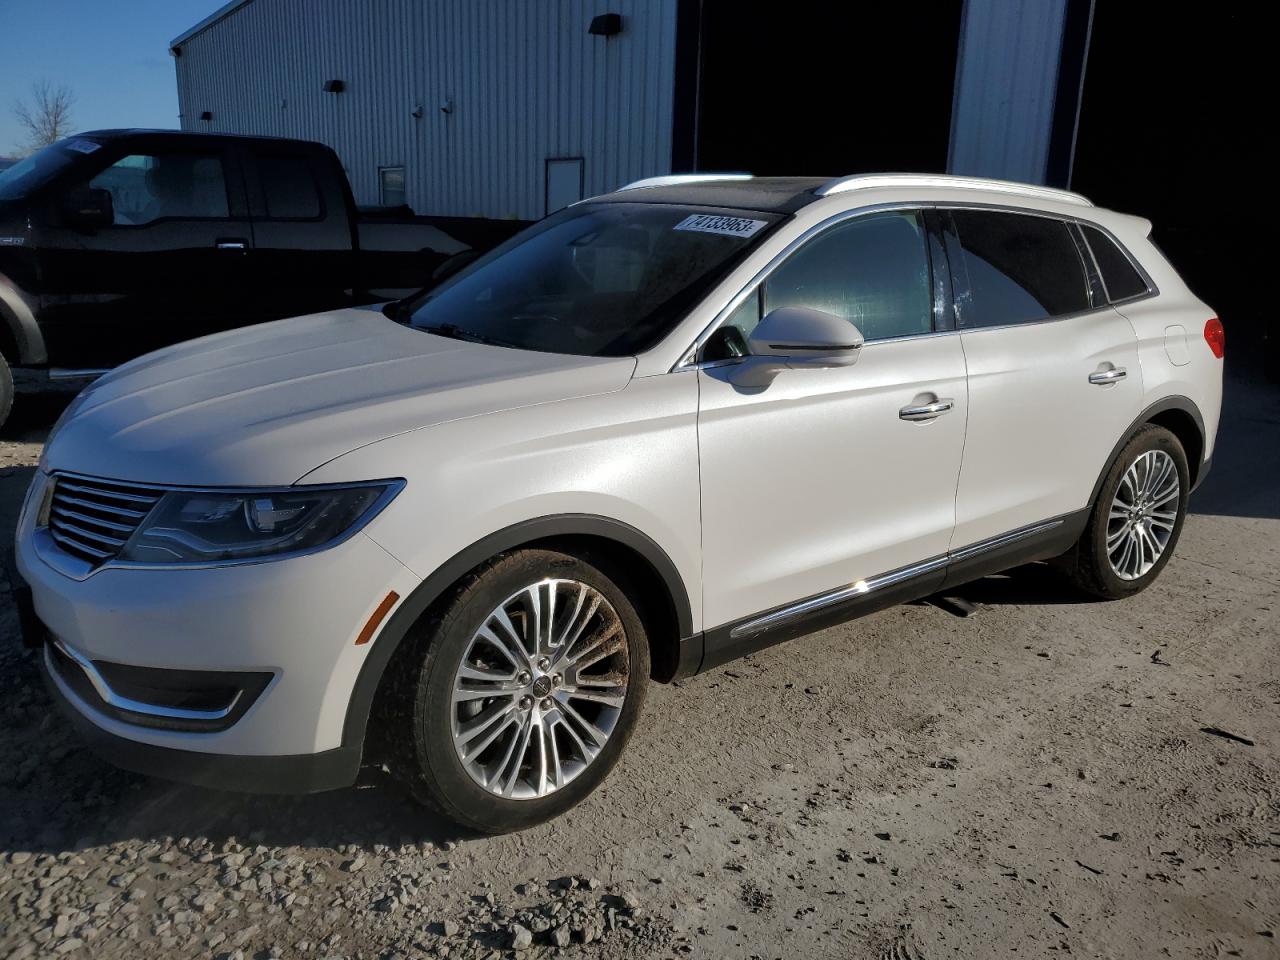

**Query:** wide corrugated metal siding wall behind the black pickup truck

left=174, top=0, right=680, bottom=219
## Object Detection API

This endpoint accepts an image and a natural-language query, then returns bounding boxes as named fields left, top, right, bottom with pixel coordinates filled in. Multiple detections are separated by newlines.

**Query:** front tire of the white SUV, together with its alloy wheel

left=379, top=549, right=649, bottom=833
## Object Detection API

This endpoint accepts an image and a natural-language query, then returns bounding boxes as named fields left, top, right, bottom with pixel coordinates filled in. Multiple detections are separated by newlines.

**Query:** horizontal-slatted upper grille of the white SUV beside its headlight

left=49, top=476, right=164, bottom=566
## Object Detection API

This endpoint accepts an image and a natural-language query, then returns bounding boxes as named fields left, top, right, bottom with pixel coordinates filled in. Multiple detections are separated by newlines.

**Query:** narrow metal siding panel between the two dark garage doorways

left=948, top=0, right=1066, bottom=183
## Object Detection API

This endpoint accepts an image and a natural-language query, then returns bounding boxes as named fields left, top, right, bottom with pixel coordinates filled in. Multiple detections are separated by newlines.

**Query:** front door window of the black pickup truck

left=88, top=154, right=229, bottom=227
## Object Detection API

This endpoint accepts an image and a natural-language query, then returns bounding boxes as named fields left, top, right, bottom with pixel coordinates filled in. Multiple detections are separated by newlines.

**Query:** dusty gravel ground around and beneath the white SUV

left=0, top=383, right=1280, bottom=960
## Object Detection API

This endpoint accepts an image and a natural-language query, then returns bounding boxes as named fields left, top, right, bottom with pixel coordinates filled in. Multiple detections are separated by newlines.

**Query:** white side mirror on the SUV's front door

left=728, top=307, right=864, bottom=387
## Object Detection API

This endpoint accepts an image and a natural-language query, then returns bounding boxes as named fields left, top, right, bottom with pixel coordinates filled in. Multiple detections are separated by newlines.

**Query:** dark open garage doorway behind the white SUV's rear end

left=1071, top=7, right=1280, bottom=366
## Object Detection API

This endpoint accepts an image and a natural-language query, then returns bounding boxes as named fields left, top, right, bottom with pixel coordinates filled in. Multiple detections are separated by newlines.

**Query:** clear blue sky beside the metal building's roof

left=0, top=0, right=224, bottom=155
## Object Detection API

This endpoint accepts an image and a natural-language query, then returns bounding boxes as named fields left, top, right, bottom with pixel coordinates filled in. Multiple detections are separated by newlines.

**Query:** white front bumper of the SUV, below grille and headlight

left=17, top=481, right=420, bottom=773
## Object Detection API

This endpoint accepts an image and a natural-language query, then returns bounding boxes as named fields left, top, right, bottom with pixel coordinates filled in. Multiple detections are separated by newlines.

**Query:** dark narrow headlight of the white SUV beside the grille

left=120, top=480, right=404, bottom=563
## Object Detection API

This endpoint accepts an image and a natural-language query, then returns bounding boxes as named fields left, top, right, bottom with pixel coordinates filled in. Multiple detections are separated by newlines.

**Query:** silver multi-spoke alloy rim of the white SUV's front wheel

left=449, top=579, right=630, bottom=800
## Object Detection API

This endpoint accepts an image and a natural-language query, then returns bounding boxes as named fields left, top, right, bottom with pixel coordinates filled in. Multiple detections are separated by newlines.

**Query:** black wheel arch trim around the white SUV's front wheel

left=342, top=515, right=701, bottom=749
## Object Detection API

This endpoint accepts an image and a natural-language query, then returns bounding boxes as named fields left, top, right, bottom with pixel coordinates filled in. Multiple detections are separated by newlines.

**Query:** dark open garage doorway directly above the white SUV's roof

left=681, top=0, right=961, bottom=177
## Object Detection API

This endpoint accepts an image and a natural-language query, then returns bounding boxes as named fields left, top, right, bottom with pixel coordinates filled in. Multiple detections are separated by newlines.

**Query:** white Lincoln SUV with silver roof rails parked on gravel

left=18, top=175, right=1222, bottom=831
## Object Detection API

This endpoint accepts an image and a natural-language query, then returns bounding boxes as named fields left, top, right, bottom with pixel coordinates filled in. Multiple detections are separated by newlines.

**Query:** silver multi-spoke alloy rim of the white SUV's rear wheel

left=1107, top=451, right=1181, bottom=580
